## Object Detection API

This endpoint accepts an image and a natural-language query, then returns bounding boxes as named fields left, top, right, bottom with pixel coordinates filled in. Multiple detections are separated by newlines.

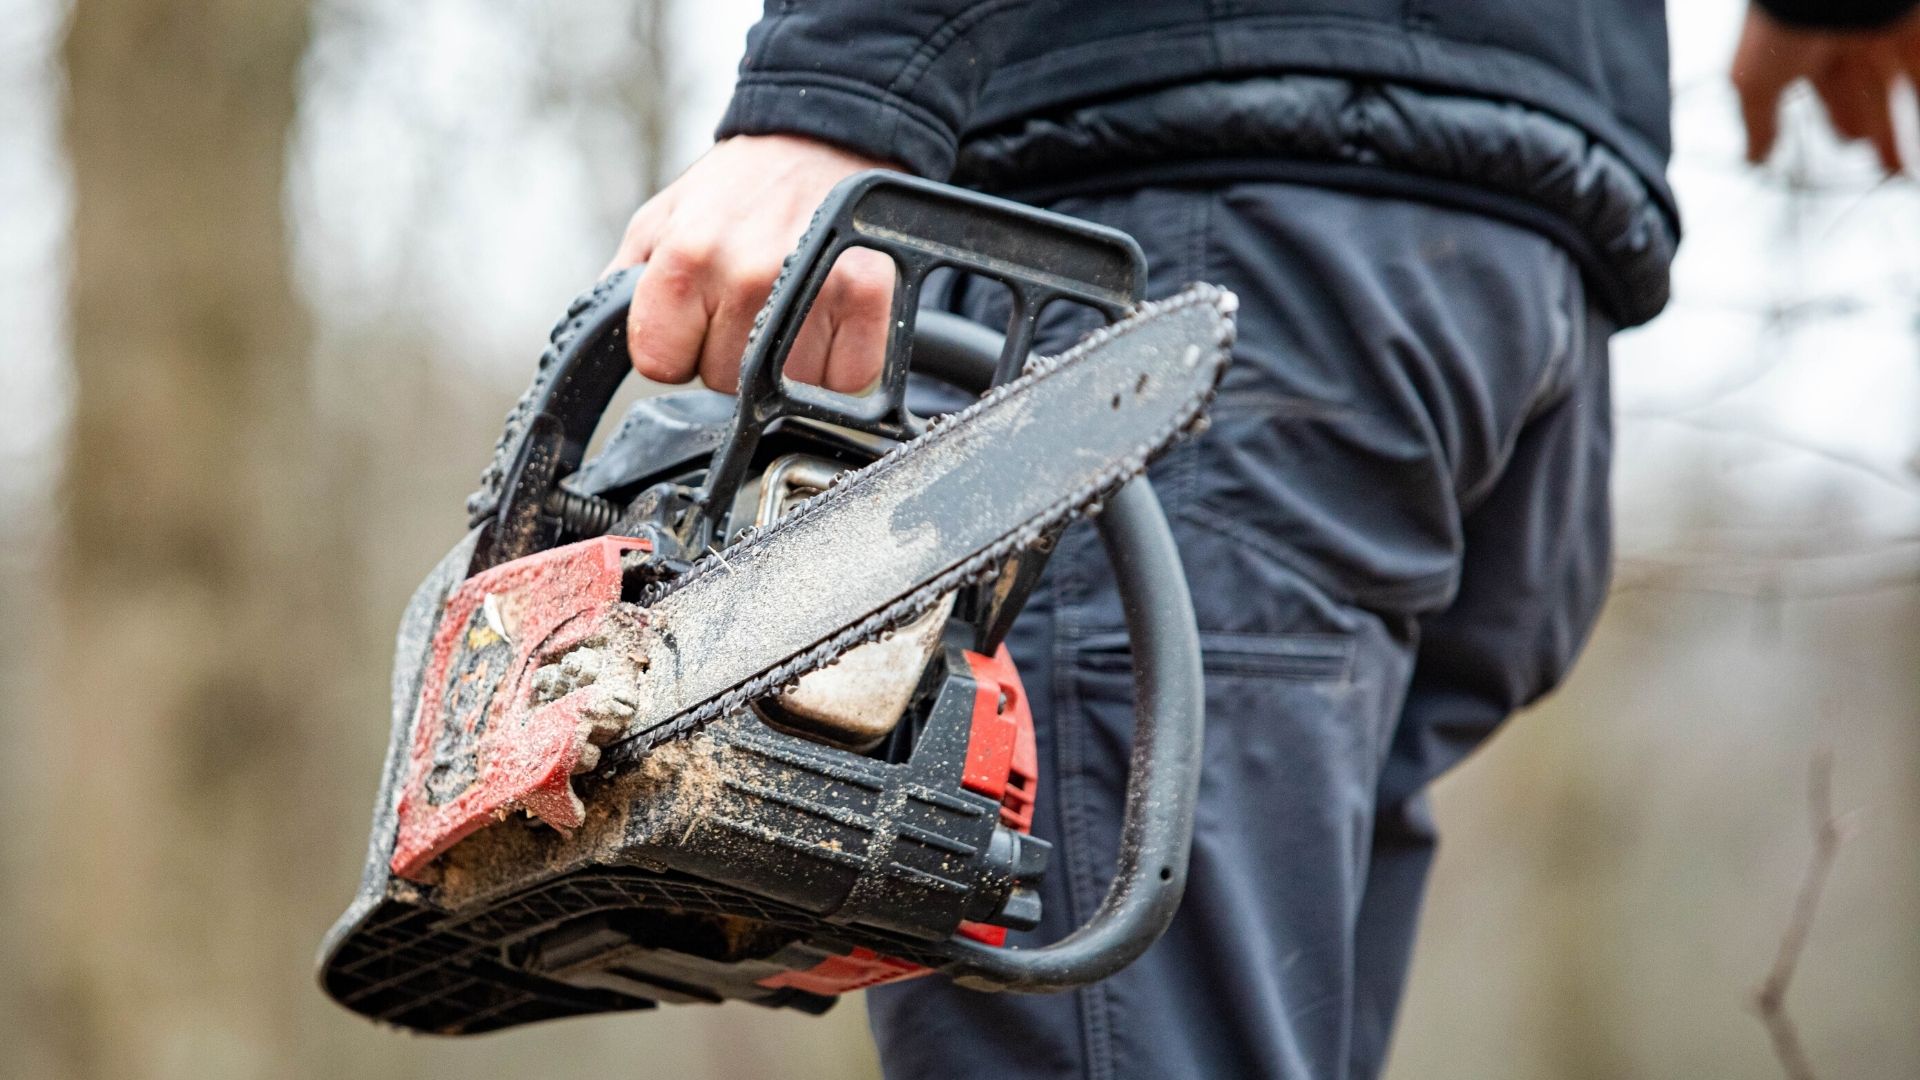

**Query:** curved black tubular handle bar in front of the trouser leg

left=914, top=311, right=1206, bottom=994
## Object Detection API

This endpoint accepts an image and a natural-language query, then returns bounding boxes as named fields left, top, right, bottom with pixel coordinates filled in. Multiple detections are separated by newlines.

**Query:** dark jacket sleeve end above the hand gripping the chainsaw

left=716, top=0, right=1025, bottom=179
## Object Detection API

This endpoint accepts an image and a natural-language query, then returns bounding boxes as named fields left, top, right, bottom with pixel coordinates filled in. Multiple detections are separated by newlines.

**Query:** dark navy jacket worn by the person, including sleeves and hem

left=720, top=0, right=1912, bottom=325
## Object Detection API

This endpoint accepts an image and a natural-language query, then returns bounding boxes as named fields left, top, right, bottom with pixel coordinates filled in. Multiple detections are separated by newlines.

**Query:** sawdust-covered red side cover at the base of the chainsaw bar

left=390, top=536, right=651, bottom=880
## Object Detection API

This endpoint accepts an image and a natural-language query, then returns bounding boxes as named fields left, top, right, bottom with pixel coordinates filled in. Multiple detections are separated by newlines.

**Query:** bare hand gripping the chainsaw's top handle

left=607, top=135, right=893, bottom=394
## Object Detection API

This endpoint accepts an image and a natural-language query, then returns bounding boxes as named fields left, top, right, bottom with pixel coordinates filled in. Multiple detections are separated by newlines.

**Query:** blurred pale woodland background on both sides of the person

left=0, top=0, right=1920, bottom=1080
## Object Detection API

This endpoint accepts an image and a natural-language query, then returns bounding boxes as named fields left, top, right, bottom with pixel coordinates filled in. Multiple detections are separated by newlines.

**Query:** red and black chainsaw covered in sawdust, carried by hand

left=321, top=171, right=1233, bottom=1034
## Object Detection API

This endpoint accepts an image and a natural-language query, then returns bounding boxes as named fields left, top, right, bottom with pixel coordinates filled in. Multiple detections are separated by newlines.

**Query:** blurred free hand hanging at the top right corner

left=1734, top=8, right=1920, bottom=173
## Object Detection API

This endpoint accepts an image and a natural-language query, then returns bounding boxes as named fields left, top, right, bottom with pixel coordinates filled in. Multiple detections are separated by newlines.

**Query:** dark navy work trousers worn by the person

left=870, top=183, right=1613, bottom=1080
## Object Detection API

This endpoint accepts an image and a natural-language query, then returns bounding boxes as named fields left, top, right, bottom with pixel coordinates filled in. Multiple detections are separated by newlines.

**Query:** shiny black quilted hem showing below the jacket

left=954, top=75, right=1678, bottom=325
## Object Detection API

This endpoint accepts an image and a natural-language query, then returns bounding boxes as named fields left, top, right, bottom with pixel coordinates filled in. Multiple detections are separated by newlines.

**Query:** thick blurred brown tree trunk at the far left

left=34, top=0, right=330, bottom=1076
